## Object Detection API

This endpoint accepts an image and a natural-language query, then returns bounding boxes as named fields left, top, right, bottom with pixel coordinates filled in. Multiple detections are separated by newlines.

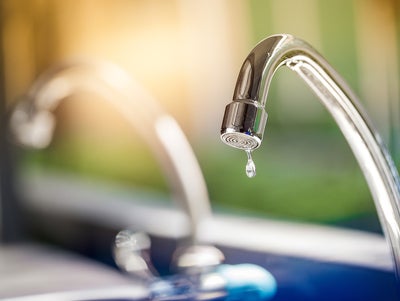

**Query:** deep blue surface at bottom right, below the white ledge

left=221, top=248, right=400, bottom=301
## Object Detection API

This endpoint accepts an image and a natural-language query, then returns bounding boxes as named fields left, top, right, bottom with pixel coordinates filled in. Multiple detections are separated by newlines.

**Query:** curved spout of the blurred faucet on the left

left=10, top=60, right=211, bottom=240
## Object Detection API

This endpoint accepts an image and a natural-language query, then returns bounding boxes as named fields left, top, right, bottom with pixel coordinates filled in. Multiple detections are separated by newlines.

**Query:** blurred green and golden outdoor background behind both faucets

left=1, top=0, right=400, bottom=231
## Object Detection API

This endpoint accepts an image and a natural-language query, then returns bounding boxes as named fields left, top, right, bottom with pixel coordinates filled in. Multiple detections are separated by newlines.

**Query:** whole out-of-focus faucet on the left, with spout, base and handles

left=10, top=61, right=276, bottom=301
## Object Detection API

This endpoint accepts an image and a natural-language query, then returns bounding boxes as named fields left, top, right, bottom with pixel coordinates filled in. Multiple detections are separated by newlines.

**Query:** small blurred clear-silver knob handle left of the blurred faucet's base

left=113, top=230, right=156, bottom=281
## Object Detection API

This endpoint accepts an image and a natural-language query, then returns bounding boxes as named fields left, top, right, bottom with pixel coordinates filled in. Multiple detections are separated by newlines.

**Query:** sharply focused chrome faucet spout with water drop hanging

left=221, top=34, right=400, bottom=279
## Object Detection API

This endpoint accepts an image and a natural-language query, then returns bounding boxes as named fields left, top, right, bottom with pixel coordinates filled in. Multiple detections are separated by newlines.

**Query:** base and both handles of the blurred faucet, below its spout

left=114, top=230, right=277, bottom=301
